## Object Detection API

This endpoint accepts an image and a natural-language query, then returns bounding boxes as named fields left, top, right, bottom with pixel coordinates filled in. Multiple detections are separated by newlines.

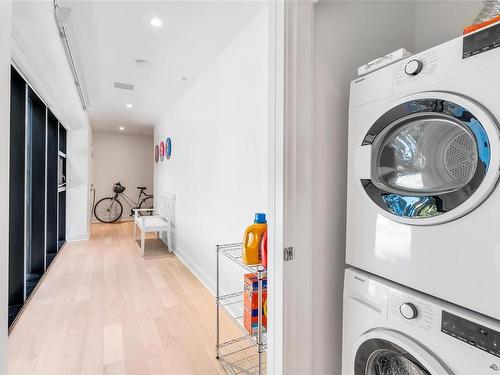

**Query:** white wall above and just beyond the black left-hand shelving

left=11, top=0, right=90, bottom=241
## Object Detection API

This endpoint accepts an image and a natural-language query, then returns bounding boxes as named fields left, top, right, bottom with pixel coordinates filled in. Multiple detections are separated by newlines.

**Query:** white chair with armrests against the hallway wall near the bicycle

left=134, top=193, right=175, bottom=256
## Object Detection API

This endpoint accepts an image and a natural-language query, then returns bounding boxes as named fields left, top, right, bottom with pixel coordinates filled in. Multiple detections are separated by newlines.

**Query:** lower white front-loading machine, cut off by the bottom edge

left=342, top=269, right=500, bottom=375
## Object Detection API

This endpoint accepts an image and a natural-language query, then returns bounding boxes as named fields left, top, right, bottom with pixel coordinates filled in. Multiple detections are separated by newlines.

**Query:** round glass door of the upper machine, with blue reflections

left=355, top=92, right=500, bottom=225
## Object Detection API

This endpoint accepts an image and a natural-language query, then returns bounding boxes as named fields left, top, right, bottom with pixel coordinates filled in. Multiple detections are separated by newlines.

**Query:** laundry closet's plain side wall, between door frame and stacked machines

left=310, top=1, right=414, bottom=374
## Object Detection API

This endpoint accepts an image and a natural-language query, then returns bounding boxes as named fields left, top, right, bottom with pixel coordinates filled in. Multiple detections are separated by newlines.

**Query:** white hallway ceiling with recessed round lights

left=59, top=0, right=265, bottom=134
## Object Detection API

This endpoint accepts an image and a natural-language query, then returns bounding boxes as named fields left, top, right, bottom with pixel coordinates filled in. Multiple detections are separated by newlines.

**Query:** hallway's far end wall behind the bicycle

left=93, top=130, right=154, bottom=220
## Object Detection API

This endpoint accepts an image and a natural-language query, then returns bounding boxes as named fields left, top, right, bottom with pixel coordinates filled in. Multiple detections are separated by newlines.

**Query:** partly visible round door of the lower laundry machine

left=354, top=330, right=451, bottom=375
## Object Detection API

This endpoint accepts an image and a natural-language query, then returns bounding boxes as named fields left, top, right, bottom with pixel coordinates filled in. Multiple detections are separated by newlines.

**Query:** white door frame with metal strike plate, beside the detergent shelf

left=268, top=0, right=316, bottom=374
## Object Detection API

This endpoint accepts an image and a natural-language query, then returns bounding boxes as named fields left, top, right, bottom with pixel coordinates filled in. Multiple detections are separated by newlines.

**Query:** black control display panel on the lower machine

left=441, top=311, right=500, bottom=357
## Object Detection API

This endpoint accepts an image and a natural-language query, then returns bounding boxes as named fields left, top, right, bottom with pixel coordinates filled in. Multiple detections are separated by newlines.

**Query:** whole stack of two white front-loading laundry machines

left=342, top=23, right=500, bottom=375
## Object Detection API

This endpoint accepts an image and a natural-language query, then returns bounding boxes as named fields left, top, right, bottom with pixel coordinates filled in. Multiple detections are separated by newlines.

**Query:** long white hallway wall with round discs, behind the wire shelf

left=155, top=10, right=268, bottom=291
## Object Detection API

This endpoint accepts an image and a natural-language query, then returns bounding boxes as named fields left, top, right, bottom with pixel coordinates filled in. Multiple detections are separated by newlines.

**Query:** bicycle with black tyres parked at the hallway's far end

left=94, top=182, right=154, bottom=224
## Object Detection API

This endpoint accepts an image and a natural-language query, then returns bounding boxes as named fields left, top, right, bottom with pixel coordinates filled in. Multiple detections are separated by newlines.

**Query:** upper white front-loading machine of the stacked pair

left=346, top=23, right=500, bottom=319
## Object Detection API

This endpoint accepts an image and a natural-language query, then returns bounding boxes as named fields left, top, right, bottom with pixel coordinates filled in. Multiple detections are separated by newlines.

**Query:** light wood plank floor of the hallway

left=8, top=223, right=236, bottom=375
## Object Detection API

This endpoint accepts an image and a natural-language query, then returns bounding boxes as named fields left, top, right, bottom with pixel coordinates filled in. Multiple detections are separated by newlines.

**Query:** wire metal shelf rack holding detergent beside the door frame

left=216, top=243, right=267, bottom=375
